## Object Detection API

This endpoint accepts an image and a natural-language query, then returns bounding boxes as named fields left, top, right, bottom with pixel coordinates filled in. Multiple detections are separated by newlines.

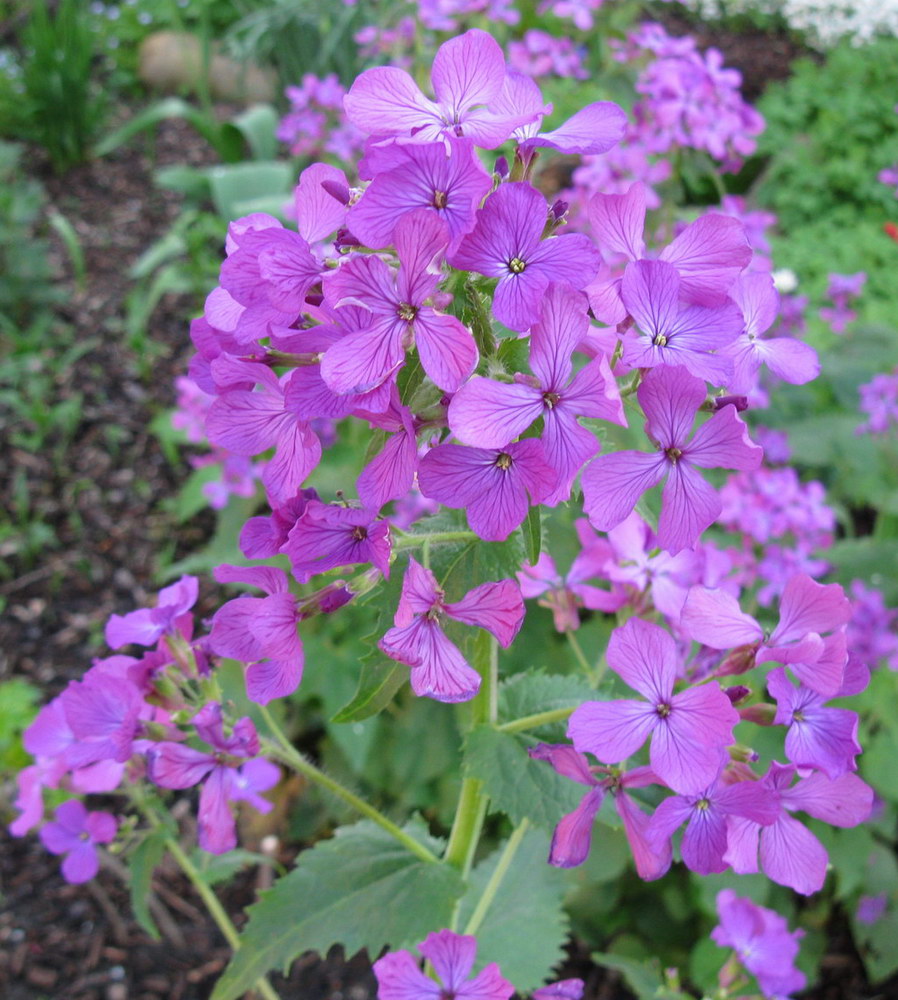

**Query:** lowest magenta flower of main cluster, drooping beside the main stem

left=378, top=558, right=524, bottom=702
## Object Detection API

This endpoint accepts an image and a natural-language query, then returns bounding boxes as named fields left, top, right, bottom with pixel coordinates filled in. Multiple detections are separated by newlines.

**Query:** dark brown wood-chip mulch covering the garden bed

left=0, top=21, right=884, bottom=1000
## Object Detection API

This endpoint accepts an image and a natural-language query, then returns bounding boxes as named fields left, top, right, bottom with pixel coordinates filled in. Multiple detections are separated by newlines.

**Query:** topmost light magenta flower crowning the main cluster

left=343, top=29, right=528, bottom=149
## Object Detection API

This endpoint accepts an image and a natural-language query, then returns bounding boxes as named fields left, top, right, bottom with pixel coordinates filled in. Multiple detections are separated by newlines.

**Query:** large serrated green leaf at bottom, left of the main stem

left=212, top=820, right=464, bottom=1000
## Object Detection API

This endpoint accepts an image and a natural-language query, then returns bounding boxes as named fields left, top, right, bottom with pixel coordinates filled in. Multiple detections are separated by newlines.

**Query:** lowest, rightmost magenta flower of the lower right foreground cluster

left=724, top=761, right=873, bottom=896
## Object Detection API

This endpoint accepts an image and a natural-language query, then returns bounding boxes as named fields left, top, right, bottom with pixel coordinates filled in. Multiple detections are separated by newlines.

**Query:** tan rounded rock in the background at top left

left=137, top=31, right=277, bottom=104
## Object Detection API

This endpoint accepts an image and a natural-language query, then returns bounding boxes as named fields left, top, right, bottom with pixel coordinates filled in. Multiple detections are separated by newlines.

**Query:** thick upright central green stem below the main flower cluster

left=444, top=632, right=499, bottom=876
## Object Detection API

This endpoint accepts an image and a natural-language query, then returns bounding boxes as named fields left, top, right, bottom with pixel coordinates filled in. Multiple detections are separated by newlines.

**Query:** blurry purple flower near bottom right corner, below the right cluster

left=711, top=889, right=807, bottom=1000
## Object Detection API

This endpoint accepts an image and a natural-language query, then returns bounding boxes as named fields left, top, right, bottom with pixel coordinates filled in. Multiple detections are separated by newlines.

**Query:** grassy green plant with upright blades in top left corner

left=0, top=0, right=106, bottom=173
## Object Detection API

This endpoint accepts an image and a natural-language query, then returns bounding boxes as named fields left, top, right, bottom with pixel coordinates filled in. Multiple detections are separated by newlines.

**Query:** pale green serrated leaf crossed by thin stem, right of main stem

left=458, top=830, right=568, bottom=992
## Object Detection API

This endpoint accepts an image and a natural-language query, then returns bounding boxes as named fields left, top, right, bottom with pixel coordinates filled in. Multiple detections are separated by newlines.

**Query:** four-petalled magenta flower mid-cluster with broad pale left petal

left=449, top=282, right=627, bottom=507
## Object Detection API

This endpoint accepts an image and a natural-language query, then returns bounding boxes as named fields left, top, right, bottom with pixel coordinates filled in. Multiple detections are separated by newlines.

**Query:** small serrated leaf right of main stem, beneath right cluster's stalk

left=464, top=726, right=584, bottom=830
